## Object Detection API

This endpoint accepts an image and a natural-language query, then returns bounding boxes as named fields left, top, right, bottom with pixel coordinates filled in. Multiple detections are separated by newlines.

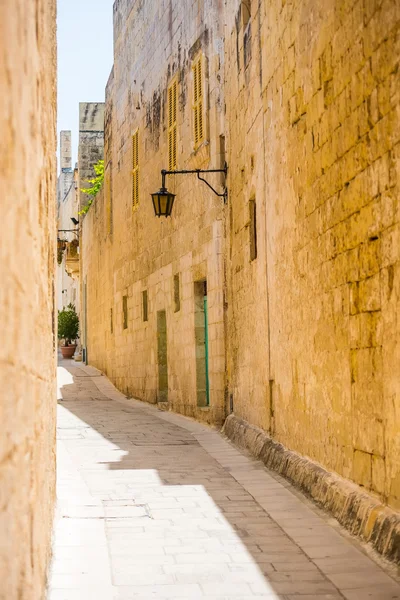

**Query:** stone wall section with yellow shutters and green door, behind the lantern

left=82, top=0, right=225, bottom=423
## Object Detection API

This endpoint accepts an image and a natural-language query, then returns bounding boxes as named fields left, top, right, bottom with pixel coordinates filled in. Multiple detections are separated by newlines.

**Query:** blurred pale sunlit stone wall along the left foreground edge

left=0, top=0, right=56, bottom=600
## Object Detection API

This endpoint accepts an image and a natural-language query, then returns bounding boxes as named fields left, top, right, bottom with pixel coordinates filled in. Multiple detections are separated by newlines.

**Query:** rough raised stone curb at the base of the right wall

left=222, top=415, right=400, bottom=564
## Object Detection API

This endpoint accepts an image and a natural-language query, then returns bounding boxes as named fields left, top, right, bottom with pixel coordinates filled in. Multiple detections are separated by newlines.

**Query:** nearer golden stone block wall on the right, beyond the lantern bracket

left=225, top=0, right=400, bottom=509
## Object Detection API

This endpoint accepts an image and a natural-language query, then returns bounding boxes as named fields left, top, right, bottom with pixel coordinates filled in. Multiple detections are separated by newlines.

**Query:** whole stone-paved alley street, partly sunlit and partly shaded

left=49, top=361, right=400, bottom=600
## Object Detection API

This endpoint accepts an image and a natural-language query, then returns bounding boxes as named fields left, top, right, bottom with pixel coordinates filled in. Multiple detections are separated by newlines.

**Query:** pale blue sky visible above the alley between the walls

left=57, top=0, right=113, bottom=164
